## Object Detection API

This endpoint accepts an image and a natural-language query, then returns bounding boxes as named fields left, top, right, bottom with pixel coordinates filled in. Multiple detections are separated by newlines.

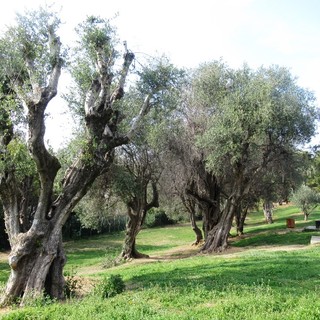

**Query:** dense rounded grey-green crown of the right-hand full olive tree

left=195, top=62, right=318, bottom=173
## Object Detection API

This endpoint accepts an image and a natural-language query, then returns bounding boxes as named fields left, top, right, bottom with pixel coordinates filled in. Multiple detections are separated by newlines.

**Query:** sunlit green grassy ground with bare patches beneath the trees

left=0, top=206, right=320, bottom=320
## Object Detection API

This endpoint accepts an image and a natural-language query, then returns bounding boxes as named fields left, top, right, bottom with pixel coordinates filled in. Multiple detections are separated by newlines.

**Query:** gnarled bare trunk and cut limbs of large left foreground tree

left=0, top=20, right=142, bottom=305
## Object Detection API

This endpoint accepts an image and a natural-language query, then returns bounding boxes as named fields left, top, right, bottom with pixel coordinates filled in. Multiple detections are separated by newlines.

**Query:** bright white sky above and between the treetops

left=0, top=0, right=320, bottom=148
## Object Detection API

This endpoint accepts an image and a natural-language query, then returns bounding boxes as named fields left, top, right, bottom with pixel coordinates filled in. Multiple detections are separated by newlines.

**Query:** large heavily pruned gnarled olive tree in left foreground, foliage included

left=0, top=9, right=180, bottom=304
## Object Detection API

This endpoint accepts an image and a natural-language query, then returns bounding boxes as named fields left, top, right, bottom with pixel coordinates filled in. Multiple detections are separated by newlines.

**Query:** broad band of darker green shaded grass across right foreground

left=131, top=251, right=320, bottom=295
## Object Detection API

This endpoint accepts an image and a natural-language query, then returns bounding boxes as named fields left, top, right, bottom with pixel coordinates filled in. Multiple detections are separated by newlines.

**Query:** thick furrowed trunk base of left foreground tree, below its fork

left=1, top=224, right=66, bottom=305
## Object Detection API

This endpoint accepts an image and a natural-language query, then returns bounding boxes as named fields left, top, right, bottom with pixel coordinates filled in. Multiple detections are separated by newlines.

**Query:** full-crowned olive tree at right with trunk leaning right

left=198, top=62, right=318, bottom=252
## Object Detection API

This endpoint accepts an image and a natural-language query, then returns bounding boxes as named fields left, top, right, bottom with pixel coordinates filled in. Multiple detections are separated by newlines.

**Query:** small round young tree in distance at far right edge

left=292, top=185, right=320, bottom=221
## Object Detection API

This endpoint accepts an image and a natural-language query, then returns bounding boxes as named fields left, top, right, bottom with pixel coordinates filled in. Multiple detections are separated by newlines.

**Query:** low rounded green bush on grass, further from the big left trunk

left=94, top=274, right=126, bottom=299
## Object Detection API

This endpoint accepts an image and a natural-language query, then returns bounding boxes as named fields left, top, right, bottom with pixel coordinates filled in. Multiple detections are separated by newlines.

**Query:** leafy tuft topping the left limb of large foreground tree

left=0, top=8, right=60, bottom=90
